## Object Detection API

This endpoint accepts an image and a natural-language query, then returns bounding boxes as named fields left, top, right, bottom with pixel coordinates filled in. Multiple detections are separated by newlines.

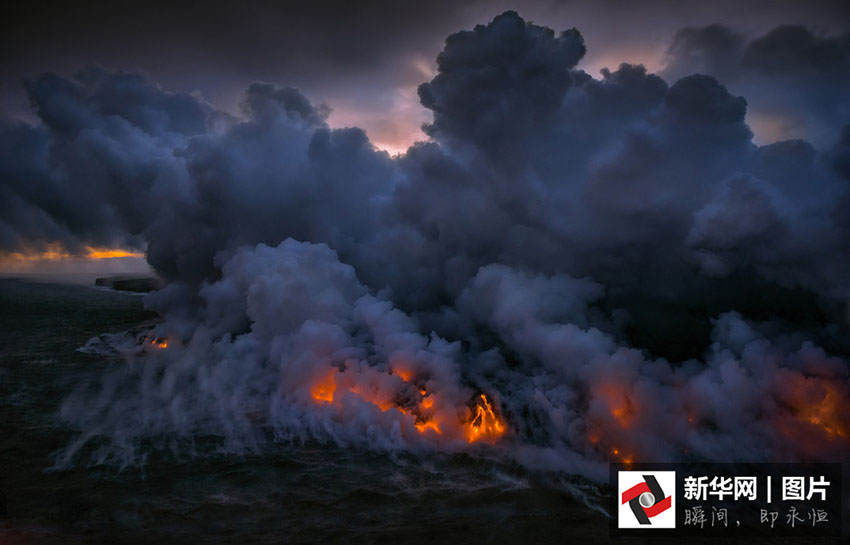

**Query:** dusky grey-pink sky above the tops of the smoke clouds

left=0, top=0, right=850, bottom=153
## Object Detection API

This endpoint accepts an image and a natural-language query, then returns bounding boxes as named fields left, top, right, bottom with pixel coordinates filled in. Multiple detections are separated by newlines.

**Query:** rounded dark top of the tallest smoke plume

left=419, top=14, right=585, bottom=148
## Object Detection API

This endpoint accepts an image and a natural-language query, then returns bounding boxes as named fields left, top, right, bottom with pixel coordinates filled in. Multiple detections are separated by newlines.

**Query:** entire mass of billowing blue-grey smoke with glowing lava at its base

left=0, top=12, right=850, bottom=476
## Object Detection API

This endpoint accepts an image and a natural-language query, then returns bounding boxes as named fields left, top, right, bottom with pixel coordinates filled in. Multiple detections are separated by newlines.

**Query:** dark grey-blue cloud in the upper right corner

left=664, top=24, right=850, bottom=146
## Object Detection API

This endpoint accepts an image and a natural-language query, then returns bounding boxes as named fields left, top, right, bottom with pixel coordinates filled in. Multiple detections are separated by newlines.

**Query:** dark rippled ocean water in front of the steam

left=0, top=279, right=624, bottom=545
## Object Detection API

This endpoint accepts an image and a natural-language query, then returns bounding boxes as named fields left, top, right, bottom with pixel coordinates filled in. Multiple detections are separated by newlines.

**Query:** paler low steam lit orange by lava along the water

left=59, top=239, right=850, bottom=477
